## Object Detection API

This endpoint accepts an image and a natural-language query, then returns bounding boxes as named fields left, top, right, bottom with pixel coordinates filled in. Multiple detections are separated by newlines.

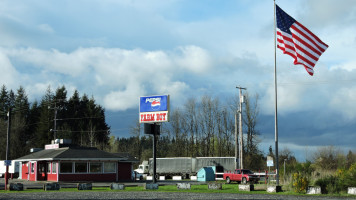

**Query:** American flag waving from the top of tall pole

left=276, top=5, right=328, bottom=76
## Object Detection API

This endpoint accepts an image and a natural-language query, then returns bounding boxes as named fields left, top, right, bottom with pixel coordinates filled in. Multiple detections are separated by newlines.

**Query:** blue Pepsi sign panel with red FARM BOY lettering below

left=140, top=95, right=169, bottom=123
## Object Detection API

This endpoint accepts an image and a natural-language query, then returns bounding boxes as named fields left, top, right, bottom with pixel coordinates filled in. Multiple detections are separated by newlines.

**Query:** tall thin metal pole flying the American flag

left=273, top=0, right=279, bottom=186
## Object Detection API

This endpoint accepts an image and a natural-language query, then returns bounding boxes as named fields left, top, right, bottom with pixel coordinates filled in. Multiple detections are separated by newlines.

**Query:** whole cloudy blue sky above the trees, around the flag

left=0, top=0, right=356, bottom=161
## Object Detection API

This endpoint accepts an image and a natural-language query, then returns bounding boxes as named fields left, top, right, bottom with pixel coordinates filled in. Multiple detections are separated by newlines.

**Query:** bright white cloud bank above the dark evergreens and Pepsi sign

left=2, top=45, right=212, bottom=110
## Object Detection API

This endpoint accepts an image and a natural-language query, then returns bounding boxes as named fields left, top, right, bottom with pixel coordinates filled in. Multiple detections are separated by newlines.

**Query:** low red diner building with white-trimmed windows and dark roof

left=16, top=140, right=139, bottom=182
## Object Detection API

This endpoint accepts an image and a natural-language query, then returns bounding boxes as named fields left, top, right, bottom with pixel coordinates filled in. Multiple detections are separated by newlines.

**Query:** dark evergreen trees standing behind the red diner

left=0, top=85, right=110, bottom=160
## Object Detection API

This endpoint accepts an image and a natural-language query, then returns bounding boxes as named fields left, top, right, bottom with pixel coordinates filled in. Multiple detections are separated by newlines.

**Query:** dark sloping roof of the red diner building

left=16, top=147, right=128, bottom=161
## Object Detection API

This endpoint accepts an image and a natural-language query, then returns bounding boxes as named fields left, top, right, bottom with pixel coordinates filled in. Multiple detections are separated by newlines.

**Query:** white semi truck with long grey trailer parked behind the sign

left=135, top=157, right=235, bottom=178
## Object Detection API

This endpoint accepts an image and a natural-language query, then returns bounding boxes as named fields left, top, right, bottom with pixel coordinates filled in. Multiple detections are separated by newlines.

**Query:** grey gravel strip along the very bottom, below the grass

left=0, top=192, right=356, bottom=200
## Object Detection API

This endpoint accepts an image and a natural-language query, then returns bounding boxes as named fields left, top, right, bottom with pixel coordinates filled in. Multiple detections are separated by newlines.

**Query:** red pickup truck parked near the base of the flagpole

left=223, top=169, right=260, bottom=184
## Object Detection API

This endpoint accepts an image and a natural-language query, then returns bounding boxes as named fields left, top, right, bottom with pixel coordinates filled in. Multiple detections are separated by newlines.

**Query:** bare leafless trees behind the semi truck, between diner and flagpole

left=109, top=93, right=266, bottom=169
